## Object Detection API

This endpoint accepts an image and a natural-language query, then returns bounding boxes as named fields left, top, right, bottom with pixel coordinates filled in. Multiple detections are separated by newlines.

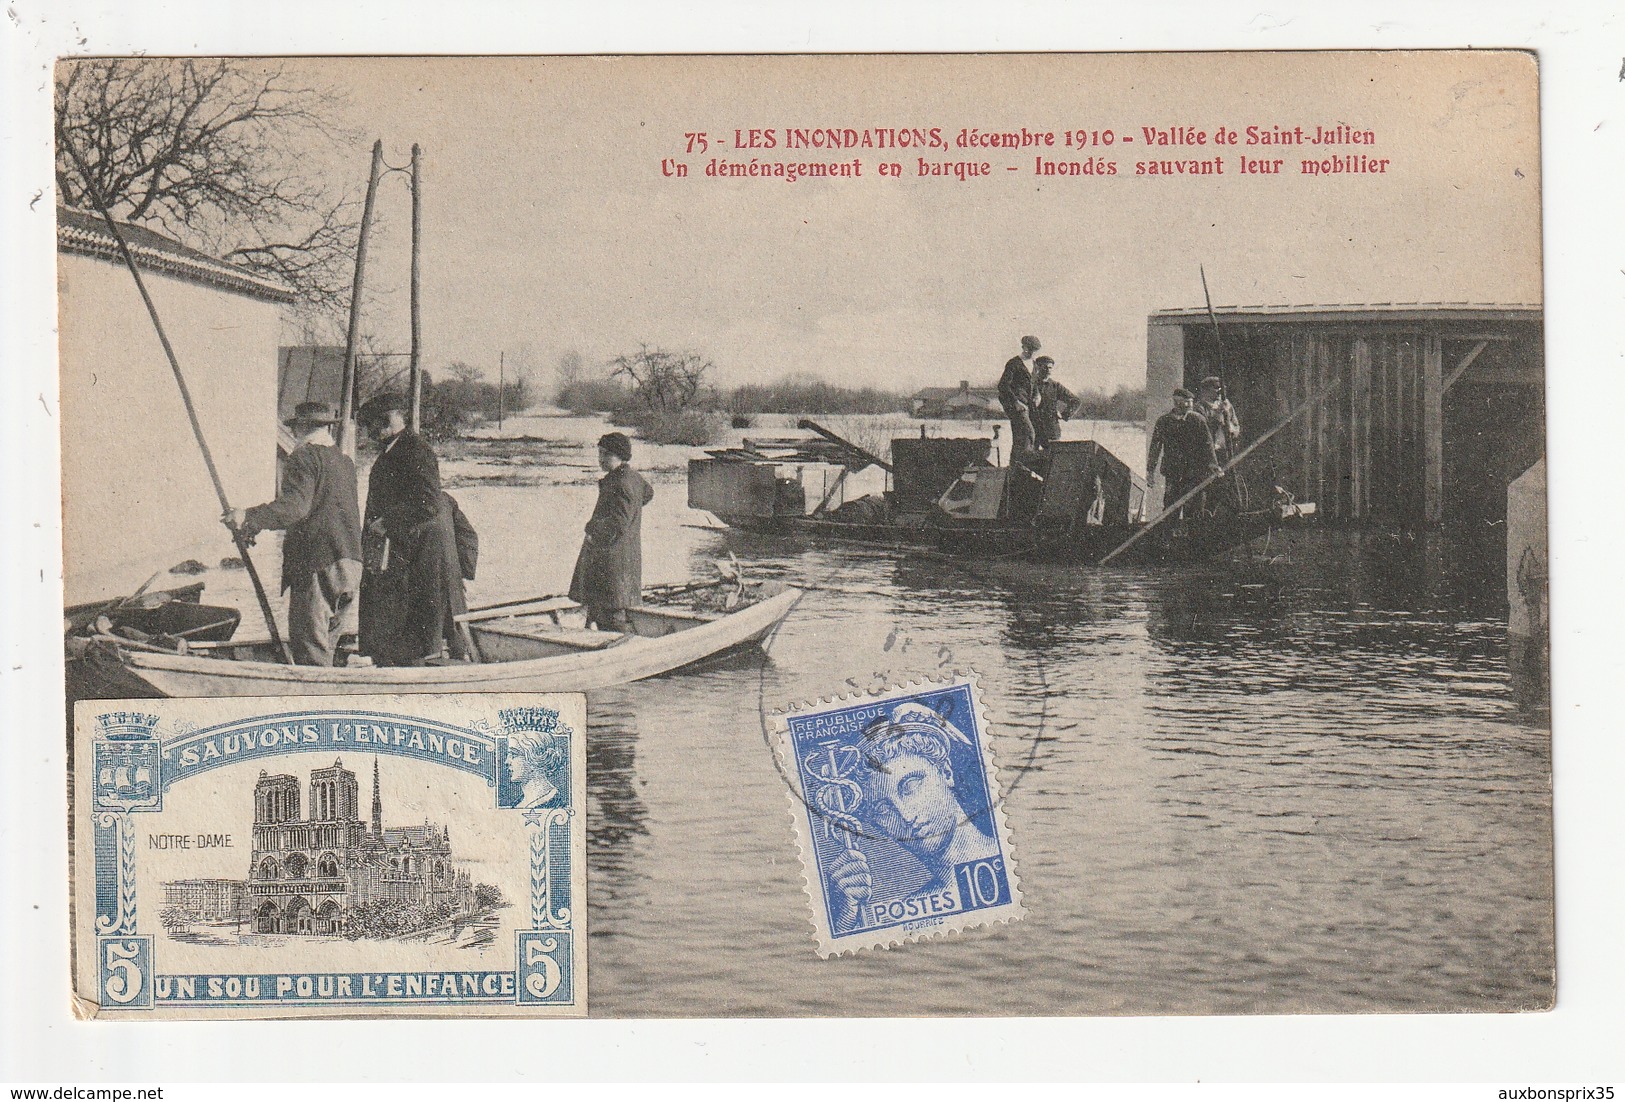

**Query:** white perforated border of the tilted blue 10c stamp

left=774, top=670, right=1027, bottom=961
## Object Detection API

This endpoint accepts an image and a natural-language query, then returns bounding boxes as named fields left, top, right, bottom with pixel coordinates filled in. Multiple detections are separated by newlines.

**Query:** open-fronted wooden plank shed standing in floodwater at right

left=1146, top=302, right=1545, bottom=528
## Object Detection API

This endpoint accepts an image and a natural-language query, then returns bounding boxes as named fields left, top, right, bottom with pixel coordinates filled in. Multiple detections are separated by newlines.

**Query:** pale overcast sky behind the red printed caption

left=299, top=52, right=1541, bottom=390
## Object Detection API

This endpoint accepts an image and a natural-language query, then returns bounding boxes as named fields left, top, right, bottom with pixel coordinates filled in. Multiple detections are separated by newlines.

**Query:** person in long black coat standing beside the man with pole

left=358, top=395, right=468, bottom=666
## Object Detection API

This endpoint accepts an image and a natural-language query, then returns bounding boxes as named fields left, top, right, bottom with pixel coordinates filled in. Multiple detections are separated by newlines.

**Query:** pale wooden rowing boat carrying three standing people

left=78, top=582, right=801, bottom=697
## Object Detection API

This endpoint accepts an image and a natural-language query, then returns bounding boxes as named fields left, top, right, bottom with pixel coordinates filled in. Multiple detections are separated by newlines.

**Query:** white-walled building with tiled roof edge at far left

left=57, top=206, right=294, bottom=605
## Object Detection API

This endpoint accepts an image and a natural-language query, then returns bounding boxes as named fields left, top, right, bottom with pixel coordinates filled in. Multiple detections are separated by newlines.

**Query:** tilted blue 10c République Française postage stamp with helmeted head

left=778, top=678, right=1022, bottom=957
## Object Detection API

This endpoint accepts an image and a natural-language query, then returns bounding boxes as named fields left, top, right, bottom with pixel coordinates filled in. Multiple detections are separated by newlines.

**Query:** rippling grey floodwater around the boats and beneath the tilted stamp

left=209, top=416, right=1554, bottom=1016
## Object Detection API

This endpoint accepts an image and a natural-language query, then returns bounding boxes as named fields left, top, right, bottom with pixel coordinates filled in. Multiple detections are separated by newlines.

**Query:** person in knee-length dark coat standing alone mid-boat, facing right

left=570, top=432, right=655, bottom=631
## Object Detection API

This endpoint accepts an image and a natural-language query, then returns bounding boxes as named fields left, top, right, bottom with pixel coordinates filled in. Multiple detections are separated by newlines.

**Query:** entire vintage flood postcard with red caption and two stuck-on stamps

left=55, top=49, right=1555, bottom=1017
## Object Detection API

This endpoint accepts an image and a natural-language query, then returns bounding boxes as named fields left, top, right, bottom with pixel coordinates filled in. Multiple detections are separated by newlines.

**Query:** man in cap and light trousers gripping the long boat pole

left=226, top=401, right=361, bottom=666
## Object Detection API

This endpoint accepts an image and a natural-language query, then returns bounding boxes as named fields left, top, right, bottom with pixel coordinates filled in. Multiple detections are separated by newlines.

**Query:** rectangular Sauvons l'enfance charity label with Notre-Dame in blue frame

left=73, top=692, right=587, bottom=1019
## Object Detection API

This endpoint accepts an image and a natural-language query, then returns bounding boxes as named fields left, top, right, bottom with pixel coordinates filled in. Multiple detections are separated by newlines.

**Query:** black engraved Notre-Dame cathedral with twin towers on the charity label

left=247, top=761, right=475, bottom=935
